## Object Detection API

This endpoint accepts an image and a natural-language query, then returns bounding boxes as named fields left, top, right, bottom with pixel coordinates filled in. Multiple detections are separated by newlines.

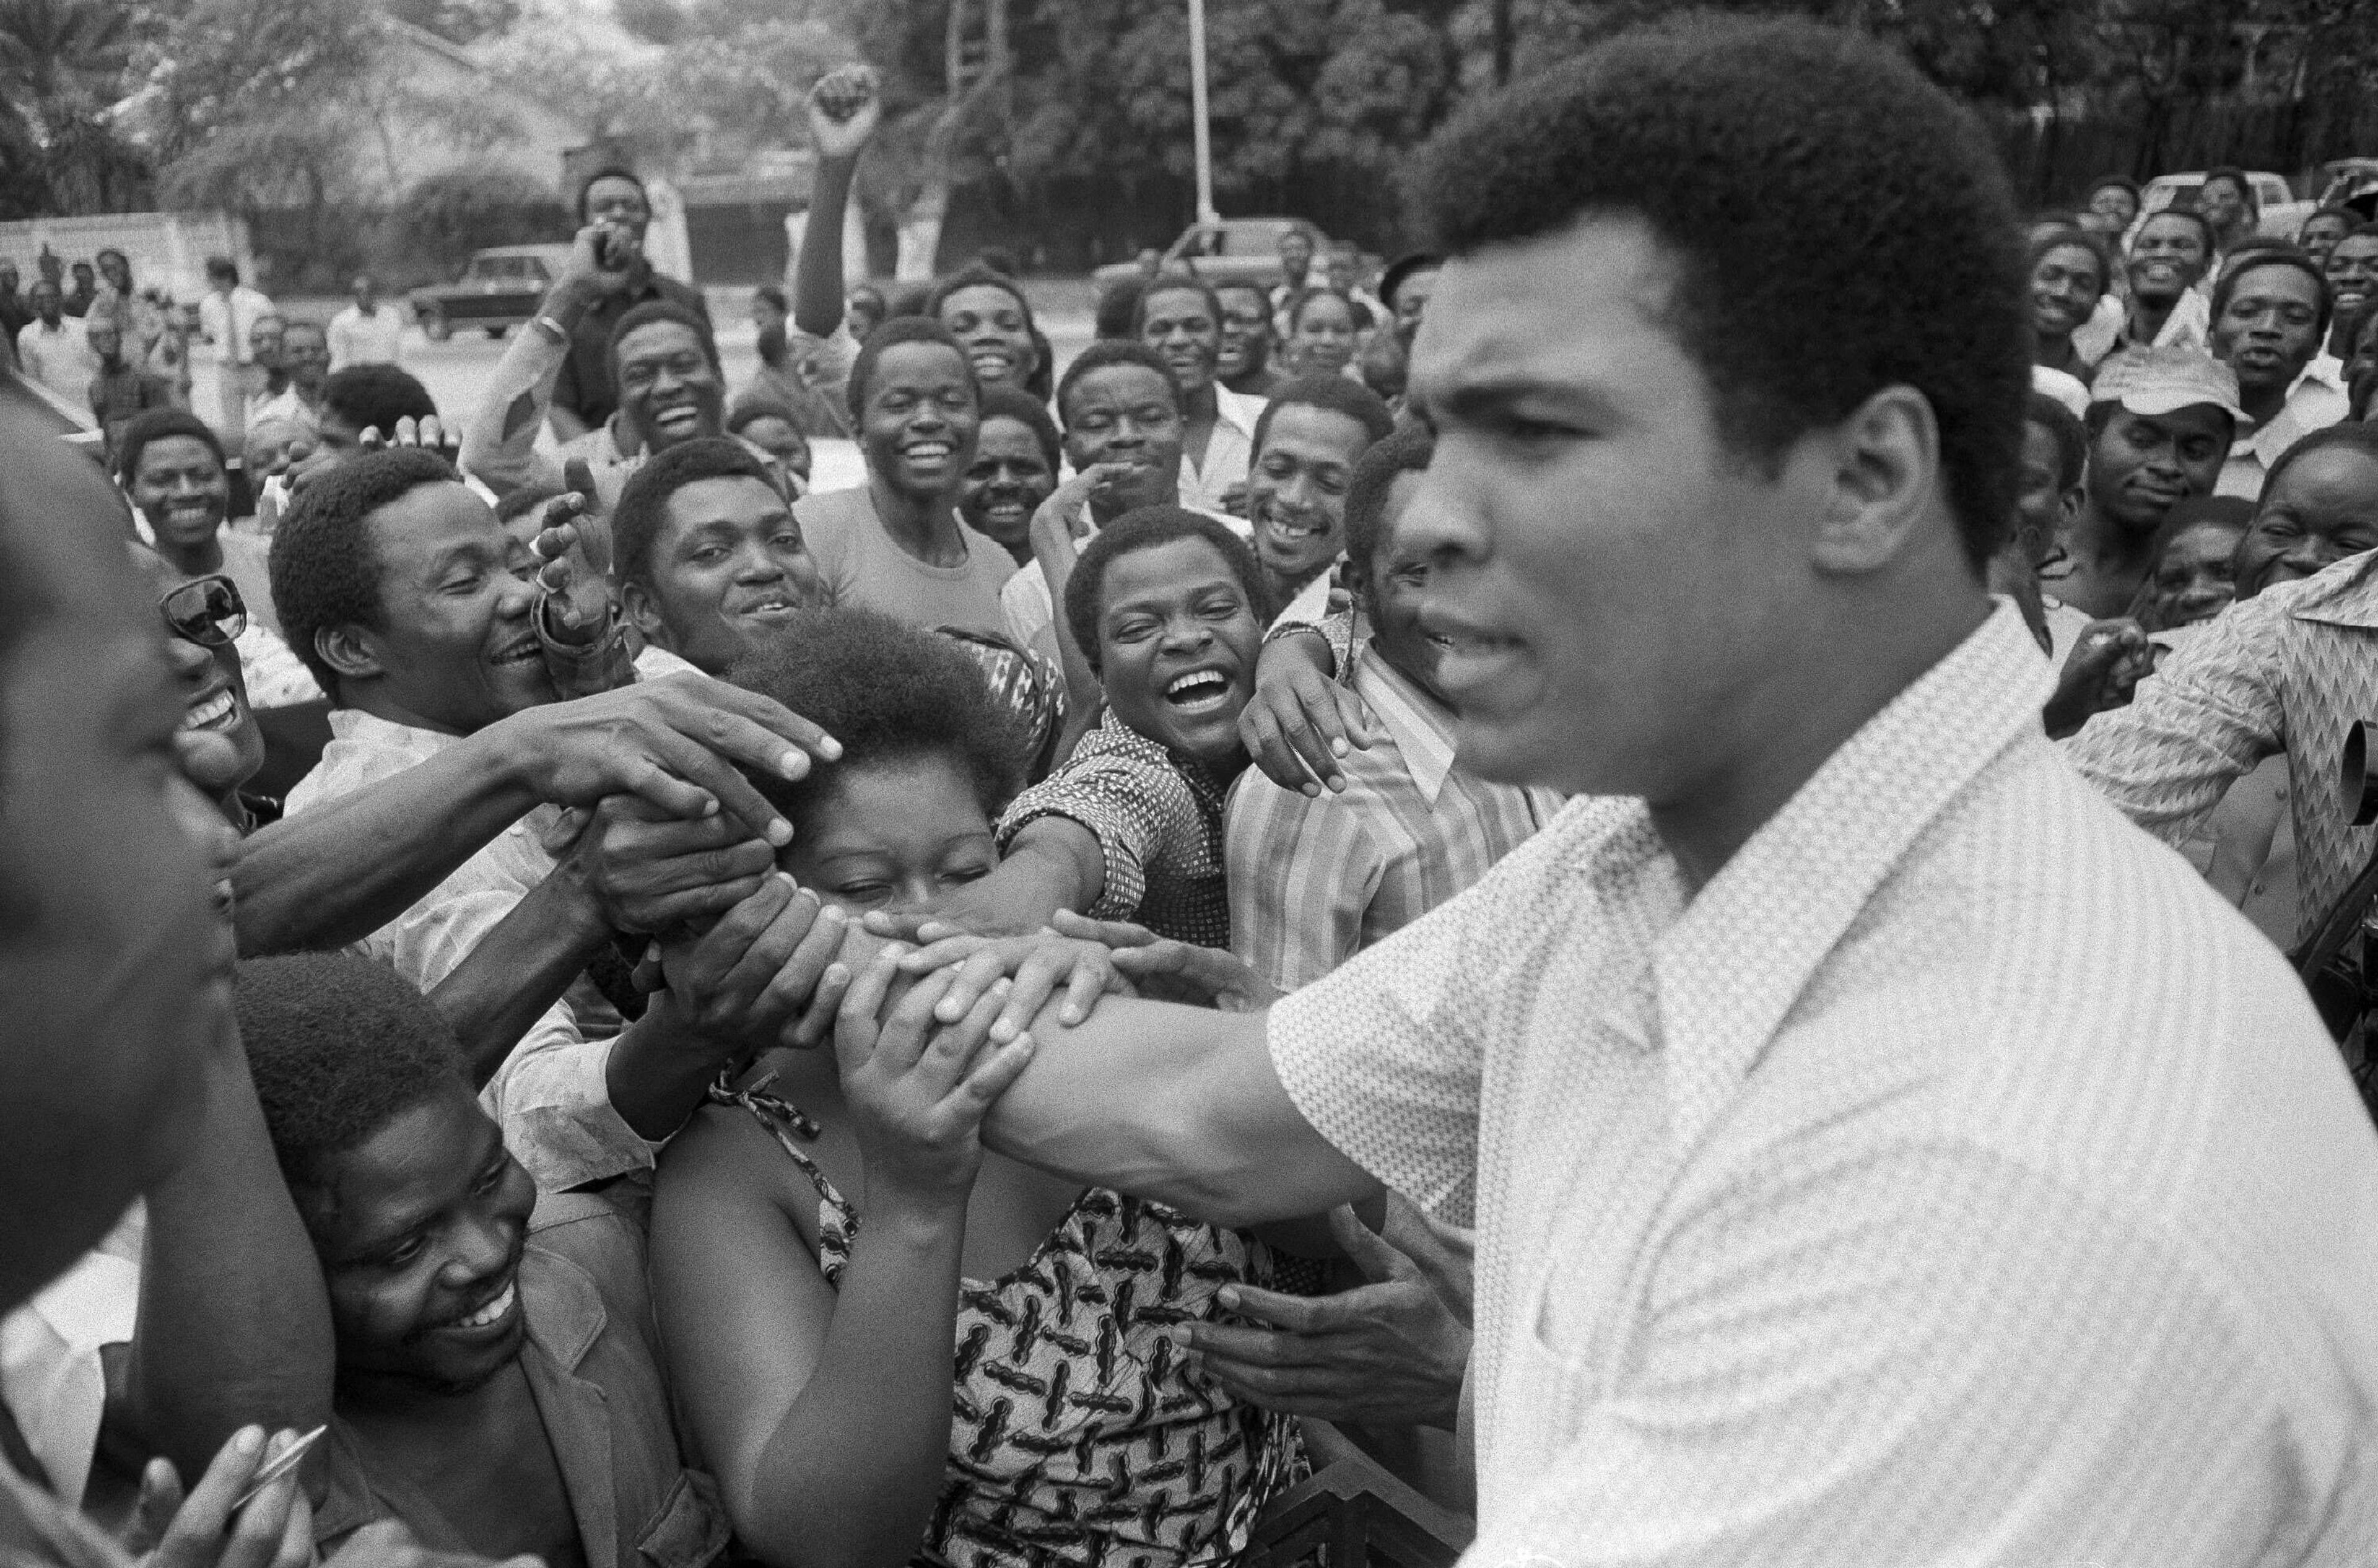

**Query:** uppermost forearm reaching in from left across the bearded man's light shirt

left=230, top=721, right=538, bottom=959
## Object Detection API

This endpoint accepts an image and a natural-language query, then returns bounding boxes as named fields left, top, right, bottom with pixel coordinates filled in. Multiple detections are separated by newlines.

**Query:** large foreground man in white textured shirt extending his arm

left=840, top=22, right=2378, bottom=1566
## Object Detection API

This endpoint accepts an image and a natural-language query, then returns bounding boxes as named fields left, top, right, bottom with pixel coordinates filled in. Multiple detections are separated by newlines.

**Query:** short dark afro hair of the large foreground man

left=1410, top=17, right=2031, bottom=571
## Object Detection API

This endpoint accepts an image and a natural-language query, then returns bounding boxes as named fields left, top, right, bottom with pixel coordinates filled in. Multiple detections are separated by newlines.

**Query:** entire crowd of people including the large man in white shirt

left=0, top=19, right=2378, bottom=1568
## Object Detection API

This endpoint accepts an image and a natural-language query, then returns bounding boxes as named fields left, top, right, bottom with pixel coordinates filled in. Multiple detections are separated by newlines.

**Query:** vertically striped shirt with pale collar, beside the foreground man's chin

left=1222, top=647, right=1560, bottom=990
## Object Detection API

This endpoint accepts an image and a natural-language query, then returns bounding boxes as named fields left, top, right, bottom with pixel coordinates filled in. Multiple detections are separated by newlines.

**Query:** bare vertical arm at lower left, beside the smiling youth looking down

left=124, top=1042, right=335, bottom=1478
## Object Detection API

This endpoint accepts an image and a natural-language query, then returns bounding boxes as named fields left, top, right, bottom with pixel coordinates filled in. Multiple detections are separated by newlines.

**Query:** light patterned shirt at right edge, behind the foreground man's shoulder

left=2064, top=552, right=2378, bottom=943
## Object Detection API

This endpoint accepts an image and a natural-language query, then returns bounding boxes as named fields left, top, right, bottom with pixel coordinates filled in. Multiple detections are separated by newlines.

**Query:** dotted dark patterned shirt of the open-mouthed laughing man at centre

left=999, top=709, right=1229, bottom=947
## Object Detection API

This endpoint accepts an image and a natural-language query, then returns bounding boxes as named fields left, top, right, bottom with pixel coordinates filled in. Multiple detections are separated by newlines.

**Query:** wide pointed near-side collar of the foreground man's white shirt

left=1653, top=604, right=2050, bottom=1149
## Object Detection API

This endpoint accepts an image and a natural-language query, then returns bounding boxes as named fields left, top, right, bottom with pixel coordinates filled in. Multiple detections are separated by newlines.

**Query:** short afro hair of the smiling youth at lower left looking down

left=233, top=952, right=471, bottom=1187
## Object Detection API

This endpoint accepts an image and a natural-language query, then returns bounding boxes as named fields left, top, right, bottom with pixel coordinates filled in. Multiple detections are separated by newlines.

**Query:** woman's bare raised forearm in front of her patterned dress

left=730, top=1185, right=965, bottom=1568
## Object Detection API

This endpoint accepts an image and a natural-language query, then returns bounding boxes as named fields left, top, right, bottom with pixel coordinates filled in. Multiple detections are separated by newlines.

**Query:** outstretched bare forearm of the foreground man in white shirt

left=982, top=997, right=1377, bottom=1228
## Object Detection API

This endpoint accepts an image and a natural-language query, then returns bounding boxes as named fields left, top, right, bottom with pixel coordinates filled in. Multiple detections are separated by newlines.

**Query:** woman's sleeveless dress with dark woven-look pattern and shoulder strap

left=711, top=1085, right=1305, bottom=1568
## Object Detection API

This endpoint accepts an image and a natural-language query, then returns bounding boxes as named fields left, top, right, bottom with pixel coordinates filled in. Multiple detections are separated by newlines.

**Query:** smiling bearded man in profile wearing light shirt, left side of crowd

left=271, top=447, right=770, bottom=1192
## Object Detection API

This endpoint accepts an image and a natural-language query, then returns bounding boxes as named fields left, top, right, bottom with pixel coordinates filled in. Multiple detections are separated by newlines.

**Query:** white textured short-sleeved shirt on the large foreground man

left=1270, top=607, right=2378, bottom=1568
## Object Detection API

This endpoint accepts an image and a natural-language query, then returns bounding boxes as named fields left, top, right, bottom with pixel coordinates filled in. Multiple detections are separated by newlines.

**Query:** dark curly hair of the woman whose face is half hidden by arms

left=728, top=609, right=1025, bottom=833
